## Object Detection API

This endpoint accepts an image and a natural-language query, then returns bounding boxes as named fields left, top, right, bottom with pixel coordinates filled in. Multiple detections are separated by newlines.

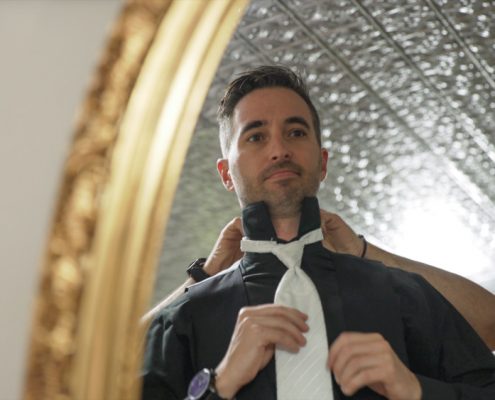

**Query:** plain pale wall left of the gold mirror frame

left=0, top=0, right=122, bottom=400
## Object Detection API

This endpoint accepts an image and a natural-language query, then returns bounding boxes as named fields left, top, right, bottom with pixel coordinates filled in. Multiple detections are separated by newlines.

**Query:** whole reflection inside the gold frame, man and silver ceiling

left=143, top=0, right=495, bottom=400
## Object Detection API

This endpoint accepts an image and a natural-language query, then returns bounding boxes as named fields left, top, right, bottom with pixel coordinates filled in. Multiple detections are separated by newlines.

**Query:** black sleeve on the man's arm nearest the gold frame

left=141, top=295, right=194, bottom=400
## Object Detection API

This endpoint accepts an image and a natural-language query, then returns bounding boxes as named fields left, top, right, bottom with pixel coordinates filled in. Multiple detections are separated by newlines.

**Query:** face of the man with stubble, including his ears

left=217, top=87, right=328, bottom=214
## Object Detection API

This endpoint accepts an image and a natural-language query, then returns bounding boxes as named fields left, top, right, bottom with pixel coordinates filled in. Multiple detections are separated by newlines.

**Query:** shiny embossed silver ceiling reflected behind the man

left=153, top=0, right=495, bottom=304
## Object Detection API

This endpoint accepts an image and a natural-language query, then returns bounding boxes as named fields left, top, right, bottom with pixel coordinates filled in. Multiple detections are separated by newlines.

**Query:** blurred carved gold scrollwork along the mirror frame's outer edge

left=24, top=0, right=170, bottom=400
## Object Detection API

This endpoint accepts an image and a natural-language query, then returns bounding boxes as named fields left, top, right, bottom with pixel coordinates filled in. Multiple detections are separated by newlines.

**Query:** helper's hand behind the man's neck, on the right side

left=320, top=209, right=364, bottom=257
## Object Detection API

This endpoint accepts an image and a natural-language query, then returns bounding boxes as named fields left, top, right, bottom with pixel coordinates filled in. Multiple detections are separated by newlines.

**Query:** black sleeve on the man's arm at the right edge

left=396, top=273, right=495, bottom=400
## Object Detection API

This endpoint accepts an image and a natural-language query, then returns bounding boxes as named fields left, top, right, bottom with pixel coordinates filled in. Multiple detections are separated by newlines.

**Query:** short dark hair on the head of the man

left=217, top=65, right=321, bottom=157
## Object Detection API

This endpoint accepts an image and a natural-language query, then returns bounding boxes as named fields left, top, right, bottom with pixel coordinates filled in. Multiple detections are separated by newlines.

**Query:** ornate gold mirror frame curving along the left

left=24, top=0, right=247, bottom=400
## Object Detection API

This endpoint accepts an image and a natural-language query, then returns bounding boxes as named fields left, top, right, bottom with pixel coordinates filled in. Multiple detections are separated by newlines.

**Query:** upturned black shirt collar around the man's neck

left=242, top=197, right=321, bottom=242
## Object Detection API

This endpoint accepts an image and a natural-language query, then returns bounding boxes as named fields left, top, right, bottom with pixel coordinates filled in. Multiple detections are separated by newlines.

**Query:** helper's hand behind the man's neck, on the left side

left=203, top=217, right=243, bottom=276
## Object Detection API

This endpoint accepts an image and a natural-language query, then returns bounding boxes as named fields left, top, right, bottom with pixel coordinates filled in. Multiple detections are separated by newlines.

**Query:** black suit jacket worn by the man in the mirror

left=144, top=247, right=495, bottom=400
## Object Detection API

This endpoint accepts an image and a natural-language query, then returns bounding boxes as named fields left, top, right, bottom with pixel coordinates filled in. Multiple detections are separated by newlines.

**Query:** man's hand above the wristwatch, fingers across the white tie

left=216, top=304, right=308, bottom=399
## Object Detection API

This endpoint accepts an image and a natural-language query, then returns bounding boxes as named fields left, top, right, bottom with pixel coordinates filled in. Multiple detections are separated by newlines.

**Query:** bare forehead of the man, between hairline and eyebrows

left=232, top=87, right=313, bottom=131
